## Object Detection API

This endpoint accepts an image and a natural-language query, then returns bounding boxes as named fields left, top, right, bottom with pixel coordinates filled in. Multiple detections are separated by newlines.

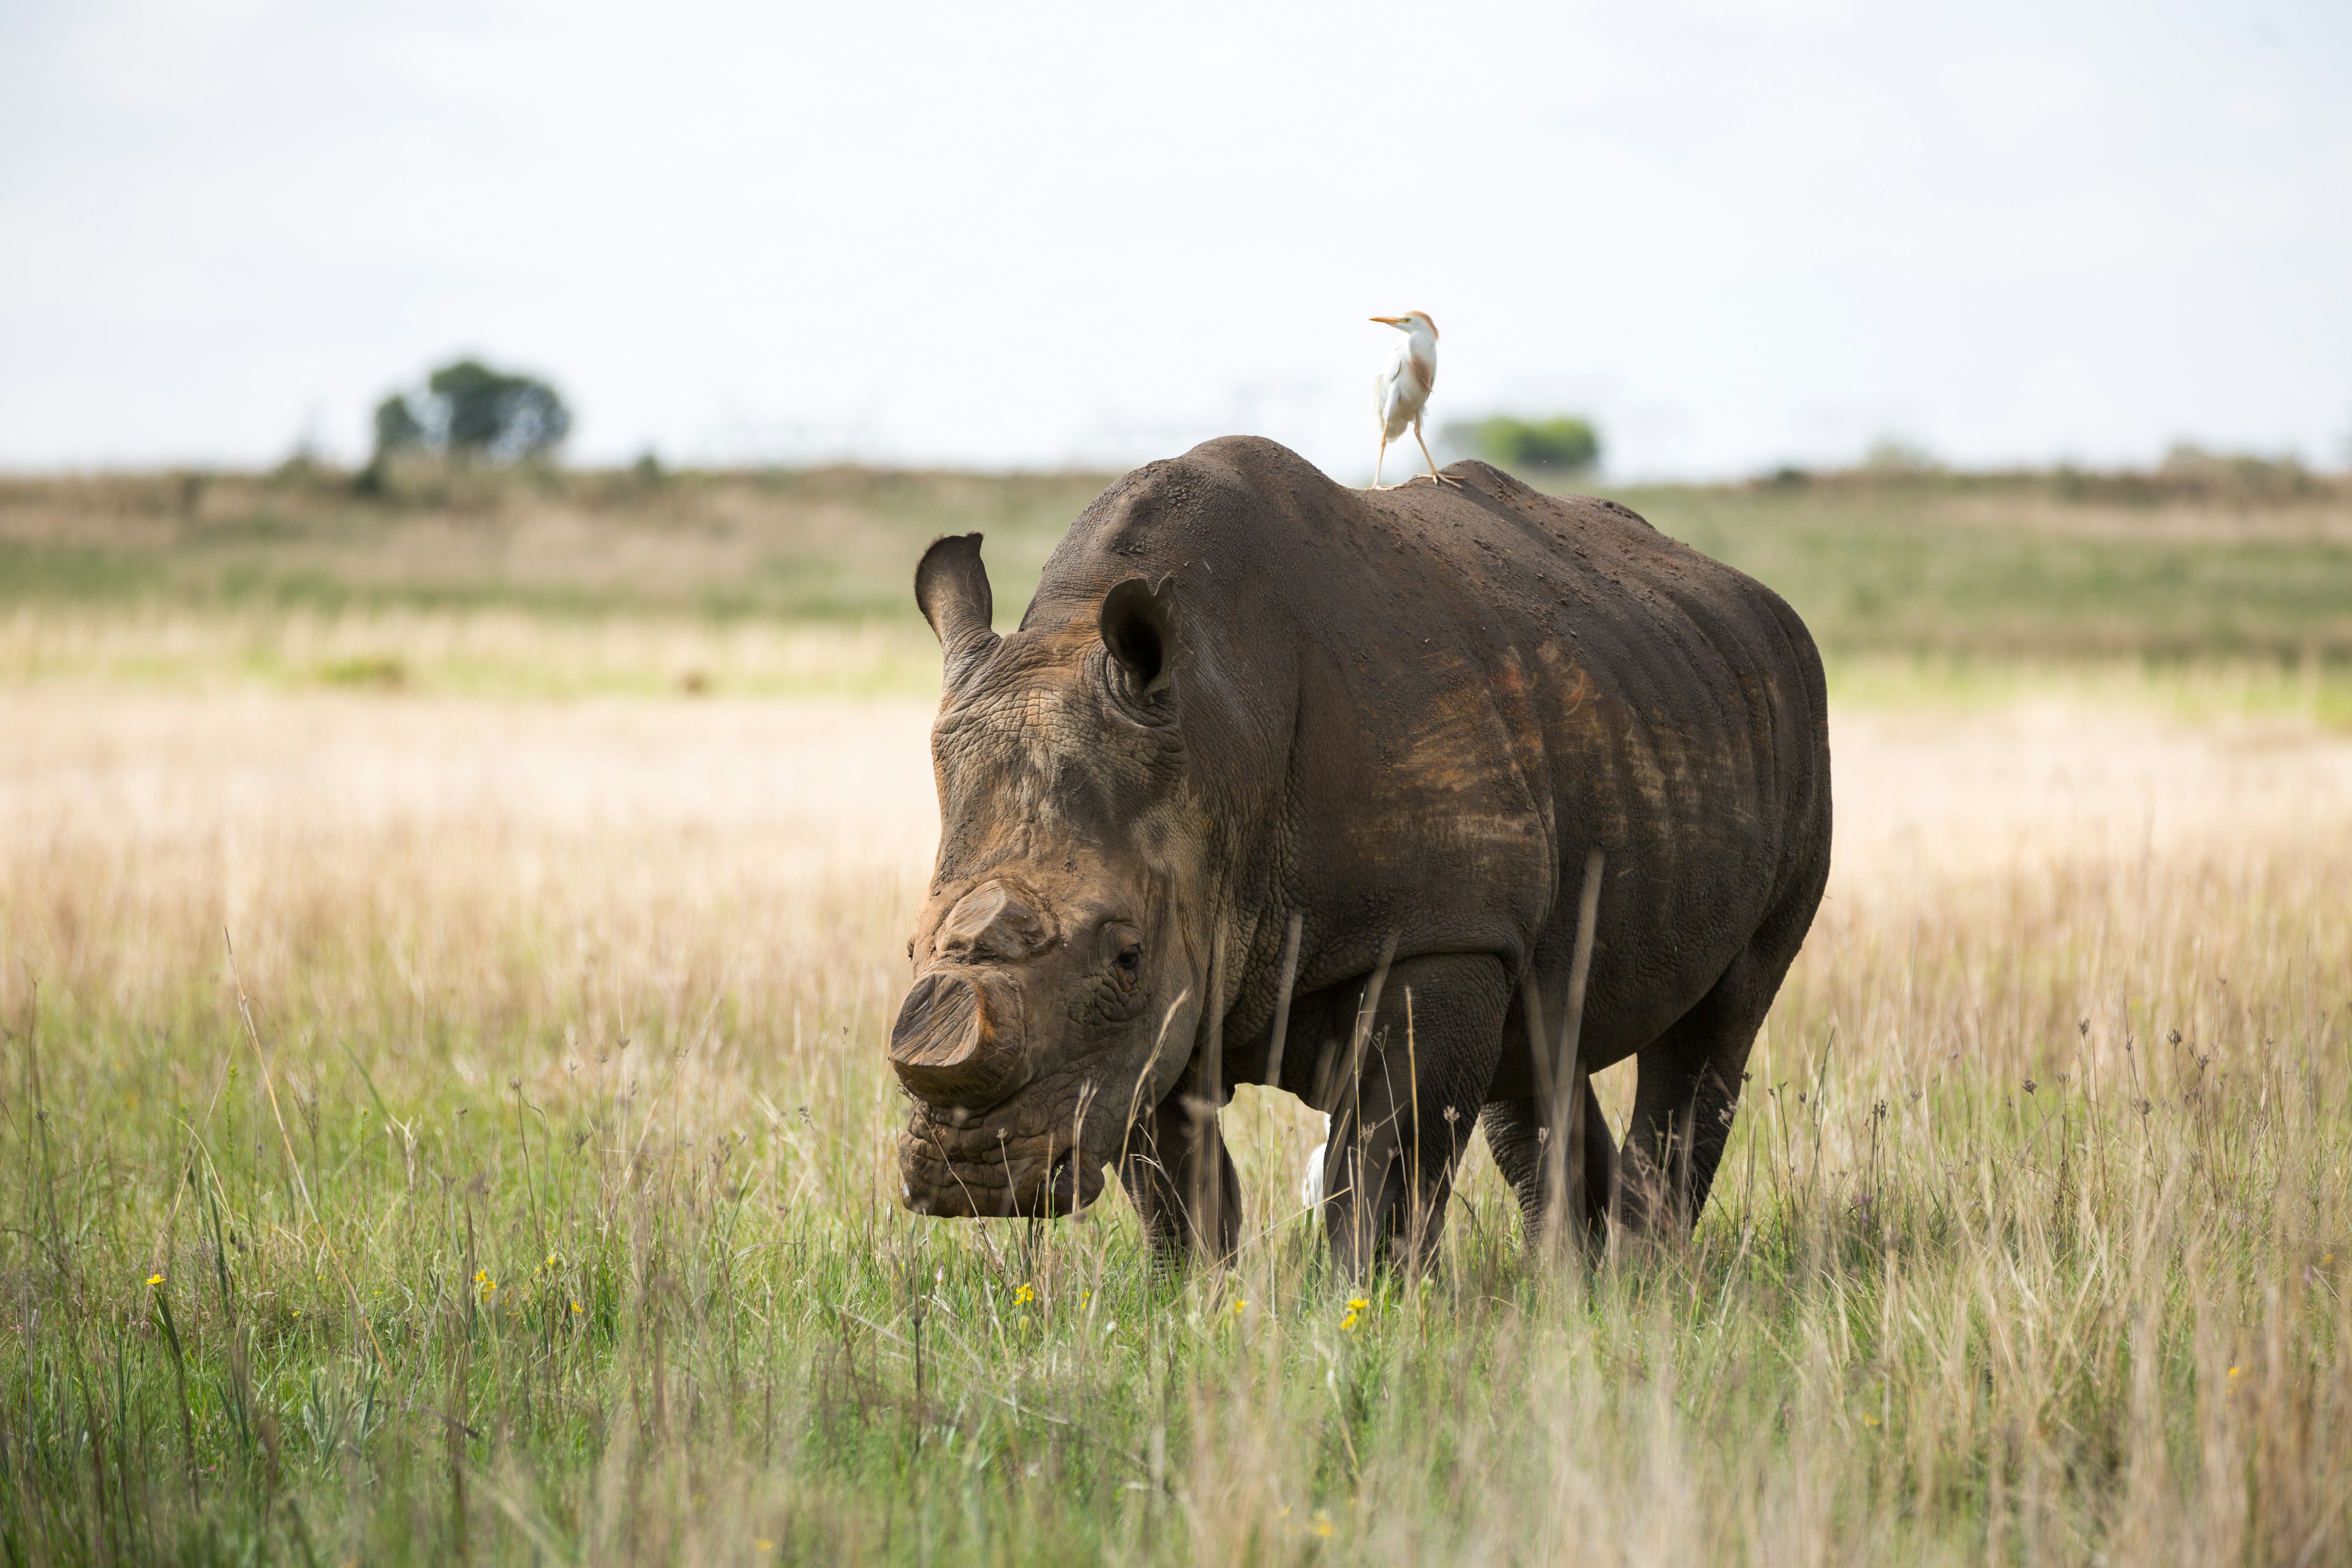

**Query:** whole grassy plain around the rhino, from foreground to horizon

left=0, top=461, right=2352, bottom=1563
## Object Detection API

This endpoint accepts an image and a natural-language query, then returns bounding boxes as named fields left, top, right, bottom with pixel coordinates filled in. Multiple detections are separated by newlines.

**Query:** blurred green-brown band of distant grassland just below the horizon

left=0, top=454, right=2352, bottom=661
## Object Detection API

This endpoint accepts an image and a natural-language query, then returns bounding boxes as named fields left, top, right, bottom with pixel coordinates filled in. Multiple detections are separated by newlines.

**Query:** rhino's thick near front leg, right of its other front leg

left=1324, top=954, right=1510, bottom=1276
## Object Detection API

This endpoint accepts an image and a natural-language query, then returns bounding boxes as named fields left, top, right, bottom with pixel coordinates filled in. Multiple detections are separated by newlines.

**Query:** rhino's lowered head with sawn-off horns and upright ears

left=889, top=533, right=1207, bottom=1215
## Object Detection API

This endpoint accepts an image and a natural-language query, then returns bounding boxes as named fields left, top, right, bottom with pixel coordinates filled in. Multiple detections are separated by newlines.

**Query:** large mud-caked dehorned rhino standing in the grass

left=891, top=437, right=1830, bottom=1270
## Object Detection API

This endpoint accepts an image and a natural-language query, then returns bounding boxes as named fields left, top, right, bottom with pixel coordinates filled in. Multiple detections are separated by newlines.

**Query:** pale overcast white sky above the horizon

left=0, top=0, right=2352, bottom=480
